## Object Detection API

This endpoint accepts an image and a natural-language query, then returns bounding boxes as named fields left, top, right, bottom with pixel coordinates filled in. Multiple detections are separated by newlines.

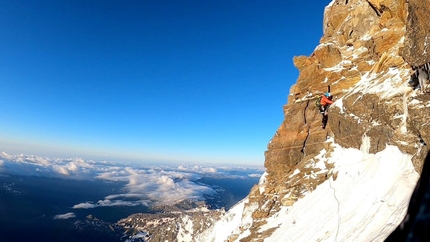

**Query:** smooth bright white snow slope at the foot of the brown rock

left=205, top=137, right=419, bottom=242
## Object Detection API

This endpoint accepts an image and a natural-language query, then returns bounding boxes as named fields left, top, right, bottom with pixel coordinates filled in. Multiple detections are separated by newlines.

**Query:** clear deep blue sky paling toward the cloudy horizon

left=0, top=0, right=330, bottom=165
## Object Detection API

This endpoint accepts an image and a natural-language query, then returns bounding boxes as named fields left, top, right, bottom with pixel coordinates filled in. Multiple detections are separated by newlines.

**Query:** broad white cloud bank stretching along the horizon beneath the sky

left=0, top=152, right=263, bottom=209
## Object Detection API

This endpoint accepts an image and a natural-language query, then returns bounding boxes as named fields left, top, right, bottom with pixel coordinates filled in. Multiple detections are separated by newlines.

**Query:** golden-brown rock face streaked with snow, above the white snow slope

left=211, top=0, right=430, bottom=241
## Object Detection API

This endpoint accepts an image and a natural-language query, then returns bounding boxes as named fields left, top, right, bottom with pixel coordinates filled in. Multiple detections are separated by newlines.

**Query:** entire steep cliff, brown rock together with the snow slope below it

left=198, top=0, right=430, bottom=242
